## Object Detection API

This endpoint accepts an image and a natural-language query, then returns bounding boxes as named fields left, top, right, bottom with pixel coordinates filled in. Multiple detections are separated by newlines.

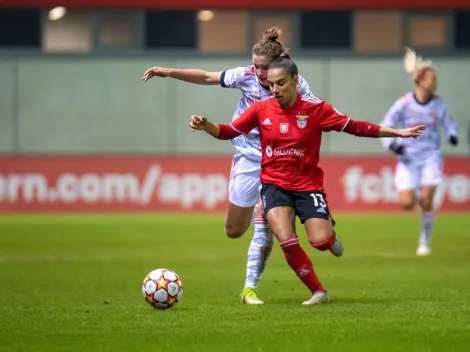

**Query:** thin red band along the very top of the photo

left=0, top=0, right=470, bottom=10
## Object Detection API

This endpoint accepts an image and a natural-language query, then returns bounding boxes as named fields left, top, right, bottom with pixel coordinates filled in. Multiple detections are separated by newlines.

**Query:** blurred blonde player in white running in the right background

left=381, top=49, right=458, bottom=256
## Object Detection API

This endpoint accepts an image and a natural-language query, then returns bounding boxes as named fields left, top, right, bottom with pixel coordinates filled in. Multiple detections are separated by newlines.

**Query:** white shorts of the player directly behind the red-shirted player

left=228, top=156, right=261, bottom=208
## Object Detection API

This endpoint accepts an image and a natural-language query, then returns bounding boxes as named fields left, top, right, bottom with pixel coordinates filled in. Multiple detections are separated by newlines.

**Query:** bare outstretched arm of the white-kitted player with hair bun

left=142, top=67, right=223, bottom=85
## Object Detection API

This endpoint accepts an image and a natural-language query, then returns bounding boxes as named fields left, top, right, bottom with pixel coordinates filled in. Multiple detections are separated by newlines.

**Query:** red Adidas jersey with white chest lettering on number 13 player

left=219, top=95, right=352, bottom=191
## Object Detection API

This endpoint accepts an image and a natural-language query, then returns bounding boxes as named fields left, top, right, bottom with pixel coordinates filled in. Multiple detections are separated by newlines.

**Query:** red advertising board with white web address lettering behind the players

left=0, top=155, right=470, bottom=214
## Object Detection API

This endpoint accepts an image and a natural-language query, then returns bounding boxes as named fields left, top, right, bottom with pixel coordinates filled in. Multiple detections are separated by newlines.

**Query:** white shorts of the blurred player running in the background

left=395, top=157, right=443, bottom=191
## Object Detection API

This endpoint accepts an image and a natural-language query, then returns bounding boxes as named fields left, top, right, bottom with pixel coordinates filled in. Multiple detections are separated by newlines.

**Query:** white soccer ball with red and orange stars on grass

left=142, top=269, right=183, bottom=309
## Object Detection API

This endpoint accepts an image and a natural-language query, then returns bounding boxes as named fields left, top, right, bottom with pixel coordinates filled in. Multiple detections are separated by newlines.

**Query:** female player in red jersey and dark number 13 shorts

left=189, top=55, right=425, bottom=304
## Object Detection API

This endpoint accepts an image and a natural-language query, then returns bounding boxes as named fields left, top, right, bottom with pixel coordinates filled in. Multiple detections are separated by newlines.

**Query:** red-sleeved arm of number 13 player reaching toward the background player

left=319, top=102, right=426, bottom=138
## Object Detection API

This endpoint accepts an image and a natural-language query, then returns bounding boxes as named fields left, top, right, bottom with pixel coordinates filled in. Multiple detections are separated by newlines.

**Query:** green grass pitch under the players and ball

left=0, top=213, right=470, bottom=352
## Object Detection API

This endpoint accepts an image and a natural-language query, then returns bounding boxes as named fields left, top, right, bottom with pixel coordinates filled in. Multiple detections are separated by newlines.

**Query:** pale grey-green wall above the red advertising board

left=0, top=57, right=470, bottom=155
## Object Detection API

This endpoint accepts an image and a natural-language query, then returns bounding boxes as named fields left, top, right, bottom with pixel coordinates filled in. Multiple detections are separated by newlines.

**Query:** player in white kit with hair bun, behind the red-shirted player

left=142, top=27, right=322, bottom=304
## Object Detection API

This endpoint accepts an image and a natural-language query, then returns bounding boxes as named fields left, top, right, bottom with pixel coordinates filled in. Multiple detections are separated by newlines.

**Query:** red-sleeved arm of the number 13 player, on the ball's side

left=189, top=102, right=261, bottom=140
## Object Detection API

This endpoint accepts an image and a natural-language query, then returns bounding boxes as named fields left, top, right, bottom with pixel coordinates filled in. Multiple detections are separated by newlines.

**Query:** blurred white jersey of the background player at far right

left=380, top=92, right=457, bottom=163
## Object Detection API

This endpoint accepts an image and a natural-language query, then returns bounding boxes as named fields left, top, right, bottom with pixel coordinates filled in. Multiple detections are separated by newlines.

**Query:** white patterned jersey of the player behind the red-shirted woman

left=220, top=66, right=313, bottom=162
